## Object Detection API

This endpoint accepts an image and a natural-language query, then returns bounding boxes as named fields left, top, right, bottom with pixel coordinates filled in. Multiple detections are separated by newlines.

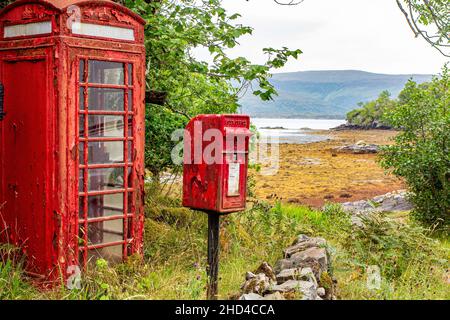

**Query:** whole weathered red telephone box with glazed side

left=0, top=0, right=145, bottom=279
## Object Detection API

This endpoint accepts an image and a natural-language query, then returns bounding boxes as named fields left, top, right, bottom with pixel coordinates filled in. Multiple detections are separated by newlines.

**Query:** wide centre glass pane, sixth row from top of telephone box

left=88, top=193, right=124, bottom=218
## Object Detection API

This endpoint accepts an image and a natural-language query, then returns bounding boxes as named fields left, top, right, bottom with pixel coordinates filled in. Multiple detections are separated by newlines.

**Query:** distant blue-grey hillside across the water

left=241, top=70, right=432, bottom=118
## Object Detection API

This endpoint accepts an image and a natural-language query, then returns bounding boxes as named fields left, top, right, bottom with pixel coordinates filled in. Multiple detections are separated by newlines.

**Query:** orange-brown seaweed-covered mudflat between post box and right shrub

left=253, top=130, right=405, bottom=207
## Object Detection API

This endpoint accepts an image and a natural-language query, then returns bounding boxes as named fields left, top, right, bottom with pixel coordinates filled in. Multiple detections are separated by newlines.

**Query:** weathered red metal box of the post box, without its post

left=183, top=115, right=252, bottom=213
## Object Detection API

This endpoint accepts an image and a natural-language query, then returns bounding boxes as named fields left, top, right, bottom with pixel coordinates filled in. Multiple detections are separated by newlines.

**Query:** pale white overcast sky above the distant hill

left=195, top=0, right=448, bottom=74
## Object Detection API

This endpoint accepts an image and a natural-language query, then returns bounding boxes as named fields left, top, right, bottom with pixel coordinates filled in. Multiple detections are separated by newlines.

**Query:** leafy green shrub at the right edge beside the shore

left=381, top=67, right=450, bottom=232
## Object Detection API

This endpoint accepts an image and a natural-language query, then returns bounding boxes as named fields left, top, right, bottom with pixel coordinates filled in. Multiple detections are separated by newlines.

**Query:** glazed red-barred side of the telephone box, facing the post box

left=72, top=51, right=139, bottom=264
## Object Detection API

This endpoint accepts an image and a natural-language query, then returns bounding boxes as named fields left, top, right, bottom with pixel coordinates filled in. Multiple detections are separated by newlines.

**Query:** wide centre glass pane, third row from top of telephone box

left=89, top=115, right=124, bottom=138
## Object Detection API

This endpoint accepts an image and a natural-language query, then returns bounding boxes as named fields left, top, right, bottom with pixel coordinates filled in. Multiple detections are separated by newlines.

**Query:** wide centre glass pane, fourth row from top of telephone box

left=88, top=141, right=124, bottom=164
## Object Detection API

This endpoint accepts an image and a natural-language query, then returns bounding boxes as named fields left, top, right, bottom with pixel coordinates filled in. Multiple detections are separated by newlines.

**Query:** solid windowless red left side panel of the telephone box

left=0, top=57, right=51, bottom=274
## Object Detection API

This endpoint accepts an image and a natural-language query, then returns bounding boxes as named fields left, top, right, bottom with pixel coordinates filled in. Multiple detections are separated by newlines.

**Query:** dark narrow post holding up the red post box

left=207, top=212, right=220, bottom=300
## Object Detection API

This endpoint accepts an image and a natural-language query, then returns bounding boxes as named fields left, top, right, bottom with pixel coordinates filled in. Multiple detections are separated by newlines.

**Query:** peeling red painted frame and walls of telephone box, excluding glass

left=0, top=0, right=145, bottom=281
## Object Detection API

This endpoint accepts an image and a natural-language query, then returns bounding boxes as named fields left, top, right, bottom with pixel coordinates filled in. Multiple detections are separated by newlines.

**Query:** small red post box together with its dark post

left=183, top=115, right=252, bottom=300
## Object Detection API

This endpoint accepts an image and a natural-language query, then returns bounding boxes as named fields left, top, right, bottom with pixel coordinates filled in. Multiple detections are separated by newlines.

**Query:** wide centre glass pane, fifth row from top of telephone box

left=88, top=168, right=124, bottom=191
